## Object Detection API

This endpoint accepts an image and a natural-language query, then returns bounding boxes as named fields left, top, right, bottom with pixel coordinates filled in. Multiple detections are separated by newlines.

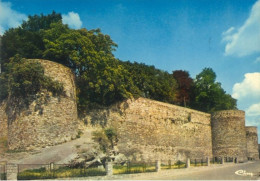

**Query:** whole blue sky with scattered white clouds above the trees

left=0, top=0, right=260, bottom=141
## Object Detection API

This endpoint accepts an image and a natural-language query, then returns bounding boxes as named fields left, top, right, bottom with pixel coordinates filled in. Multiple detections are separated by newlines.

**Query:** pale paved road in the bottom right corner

left=127, top=161, right=260, bottom=180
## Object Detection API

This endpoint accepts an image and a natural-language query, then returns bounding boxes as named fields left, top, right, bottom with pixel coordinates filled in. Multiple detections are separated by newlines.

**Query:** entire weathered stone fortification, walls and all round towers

left=0, top=59, right=259, bottom=161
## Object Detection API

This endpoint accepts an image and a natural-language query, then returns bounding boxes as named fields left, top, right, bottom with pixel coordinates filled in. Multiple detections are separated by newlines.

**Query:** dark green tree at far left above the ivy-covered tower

left=0, top=12, right=62, bottom=71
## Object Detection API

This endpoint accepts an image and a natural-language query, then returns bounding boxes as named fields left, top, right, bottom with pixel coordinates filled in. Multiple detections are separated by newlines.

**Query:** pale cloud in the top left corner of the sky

left=0, top=0, right=27, bottom=35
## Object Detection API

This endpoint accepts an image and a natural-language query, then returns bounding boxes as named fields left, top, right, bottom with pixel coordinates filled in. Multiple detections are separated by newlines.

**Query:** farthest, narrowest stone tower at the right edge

left=246, top=126, right=259, bottom=160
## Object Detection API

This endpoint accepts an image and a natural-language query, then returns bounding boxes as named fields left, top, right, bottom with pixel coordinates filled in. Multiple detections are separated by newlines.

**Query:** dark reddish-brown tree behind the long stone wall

left=172, top=70, right=193, bottom=107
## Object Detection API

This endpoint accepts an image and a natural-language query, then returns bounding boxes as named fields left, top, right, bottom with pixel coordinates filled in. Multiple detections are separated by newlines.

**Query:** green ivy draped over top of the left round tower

left=0, top=56, right=63, bottom=104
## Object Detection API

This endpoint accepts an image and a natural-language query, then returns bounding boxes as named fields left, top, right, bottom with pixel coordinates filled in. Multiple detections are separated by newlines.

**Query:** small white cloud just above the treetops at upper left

left=62, top=11, right=82, bottom=29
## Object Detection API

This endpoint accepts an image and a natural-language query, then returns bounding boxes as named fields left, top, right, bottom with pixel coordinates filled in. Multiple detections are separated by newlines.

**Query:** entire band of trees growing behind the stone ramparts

left=0, top=12, right=236, bottom=113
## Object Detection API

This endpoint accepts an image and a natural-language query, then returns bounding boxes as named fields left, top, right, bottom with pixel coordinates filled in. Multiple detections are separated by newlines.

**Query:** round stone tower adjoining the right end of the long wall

left=211, top=110, right=247, bottom=162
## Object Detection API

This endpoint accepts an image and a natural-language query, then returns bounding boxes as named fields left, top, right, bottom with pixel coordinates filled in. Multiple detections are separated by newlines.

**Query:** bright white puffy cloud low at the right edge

left=232, top=72, right=260, bottom=99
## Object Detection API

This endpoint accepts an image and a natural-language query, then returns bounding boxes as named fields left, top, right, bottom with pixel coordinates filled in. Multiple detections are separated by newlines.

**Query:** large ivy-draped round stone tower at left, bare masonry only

left=0, top=59, right=78, bottom=150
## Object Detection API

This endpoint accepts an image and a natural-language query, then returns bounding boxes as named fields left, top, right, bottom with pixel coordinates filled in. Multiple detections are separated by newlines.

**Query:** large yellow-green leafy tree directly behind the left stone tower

left=43, top=22, right=135, bottom=112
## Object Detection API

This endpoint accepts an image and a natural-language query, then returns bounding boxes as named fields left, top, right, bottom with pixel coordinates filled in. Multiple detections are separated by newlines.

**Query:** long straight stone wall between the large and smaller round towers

left=87, top=98, right=212, bottom=161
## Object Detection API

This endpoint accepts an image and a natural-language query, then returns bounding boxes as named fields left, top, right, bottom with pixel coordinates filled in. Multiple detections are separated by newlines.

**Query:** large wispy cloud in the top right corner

left=222, top=0, right=260, bottom=57
